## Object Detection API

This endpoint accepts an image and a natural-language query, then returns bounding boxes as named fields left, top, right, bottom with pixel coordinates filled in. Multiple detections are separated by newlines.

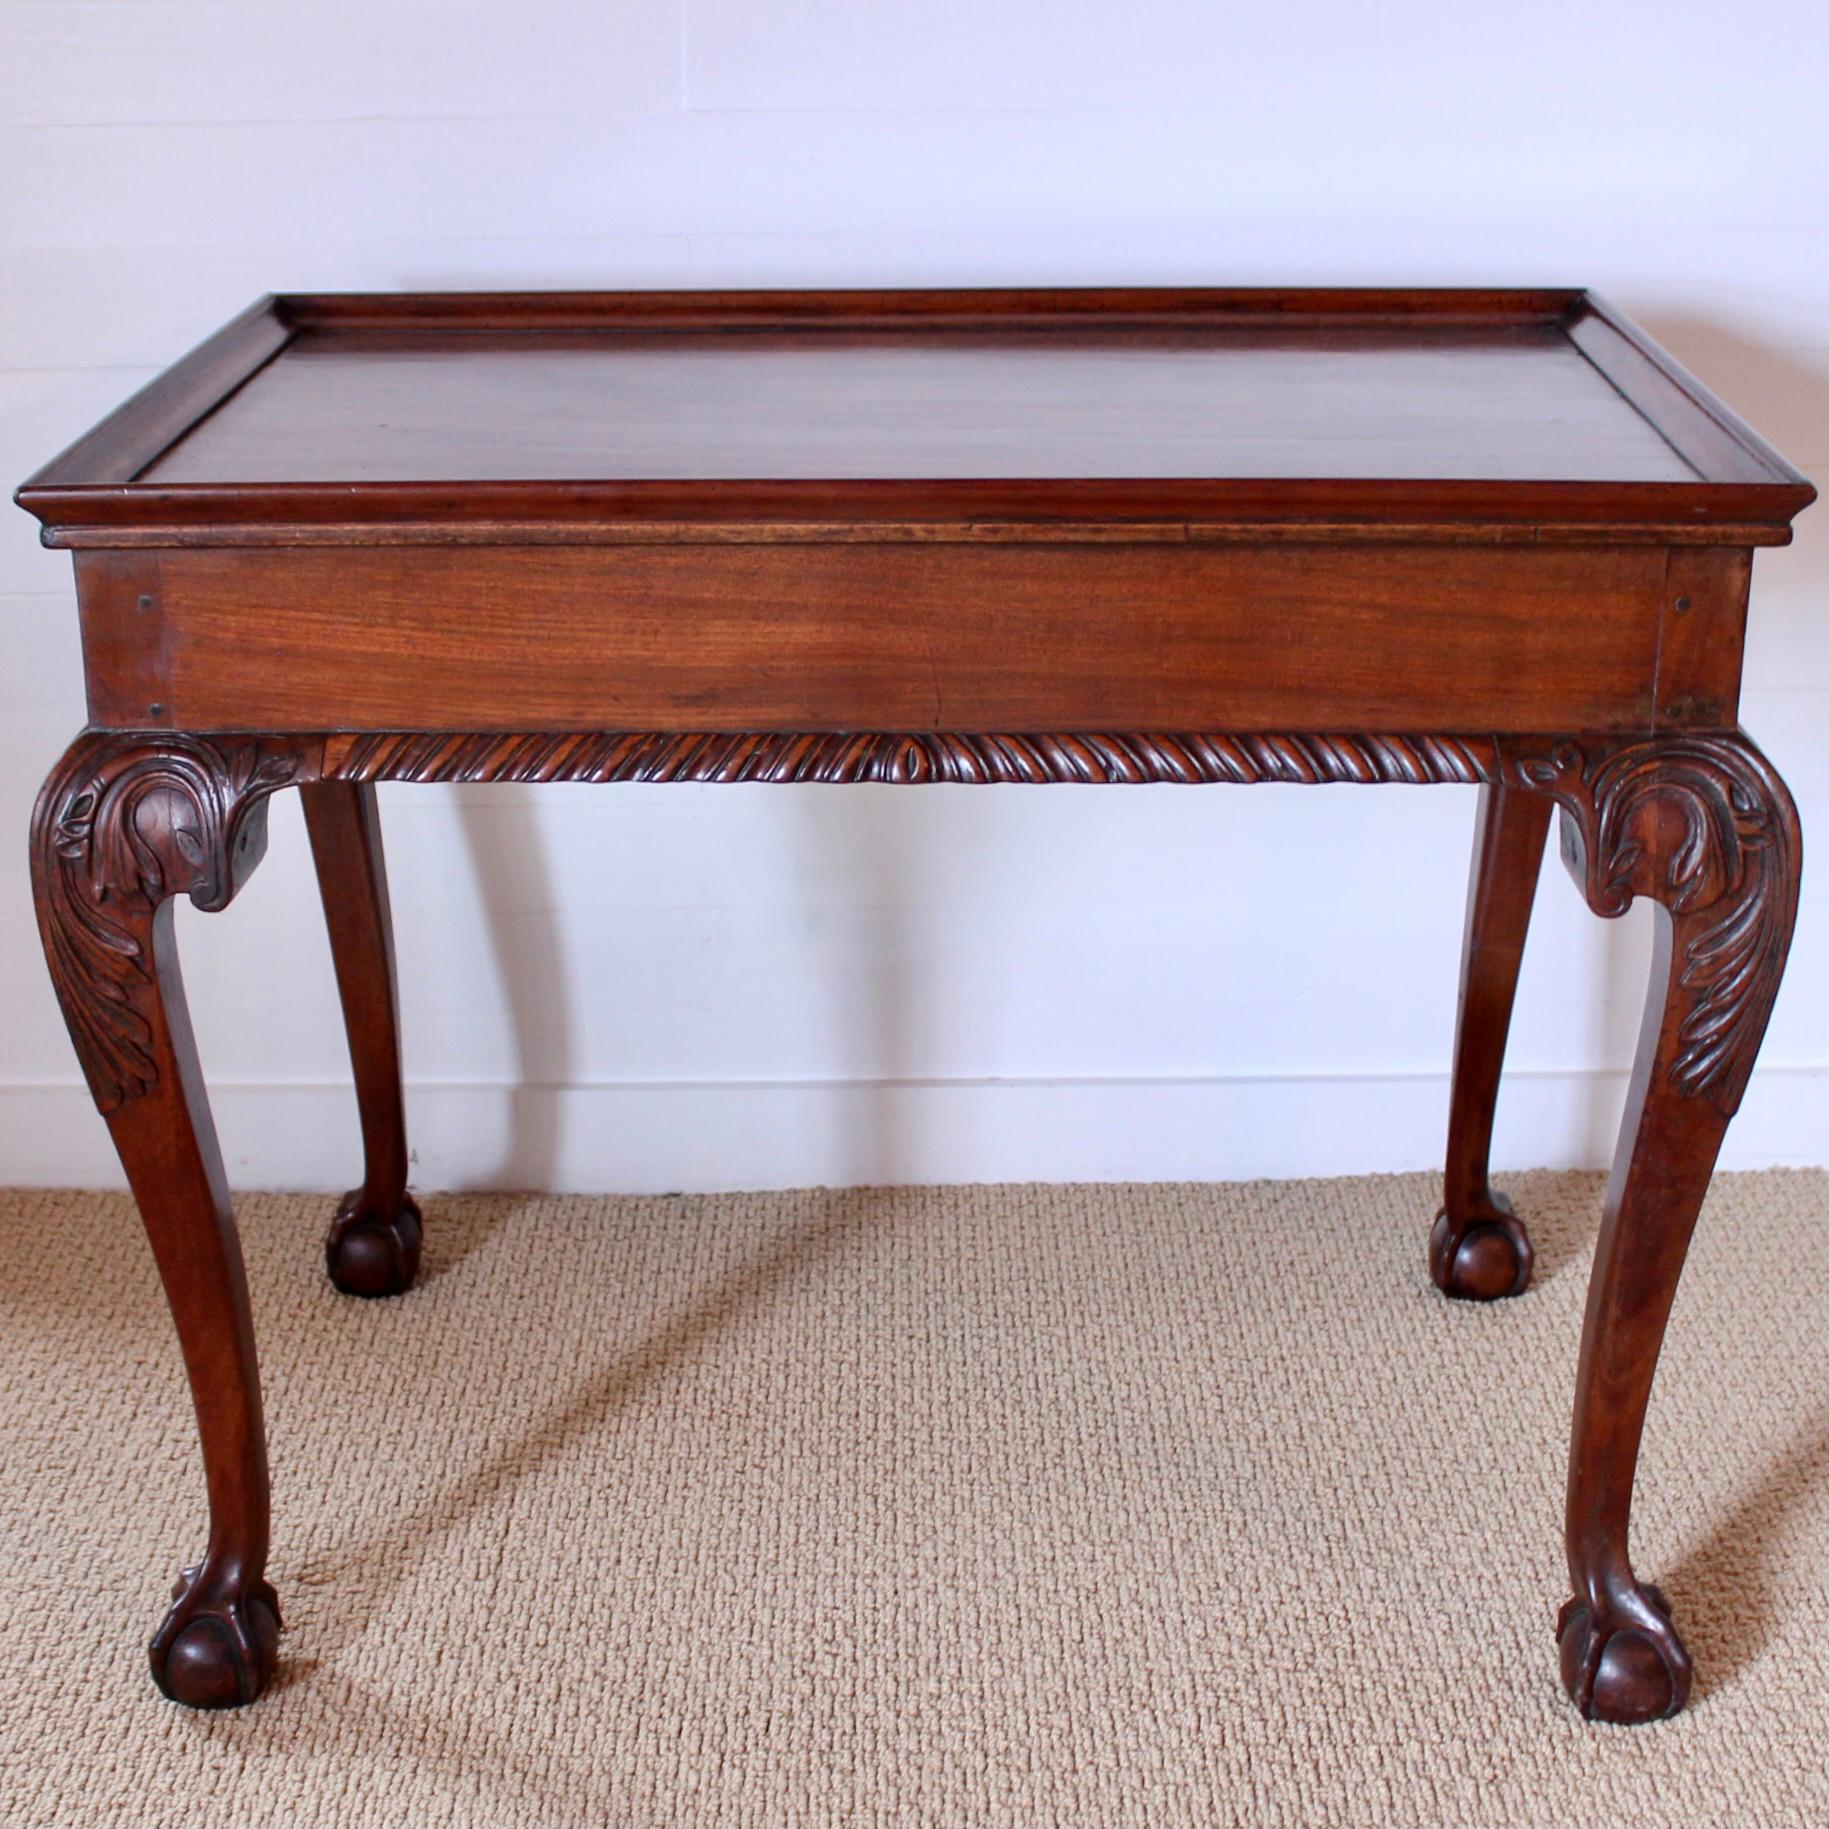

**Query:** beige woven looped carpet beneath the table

left=0, top=1172, right=1829, bottom=1829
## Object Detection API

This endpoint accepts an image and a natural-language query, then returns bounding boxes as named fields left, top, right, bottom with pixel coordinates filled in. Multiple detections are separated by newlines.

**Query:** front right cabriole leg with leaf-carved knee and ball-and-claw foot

left=1505, top=732, right=1802, bottom=1723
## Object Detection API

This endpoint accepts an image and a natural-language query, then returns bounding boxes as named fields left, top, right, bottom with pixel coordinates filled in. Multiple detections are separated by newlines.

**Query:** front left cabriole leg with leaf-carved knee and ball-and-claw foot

left=31, top=732, right=305, bottom=1708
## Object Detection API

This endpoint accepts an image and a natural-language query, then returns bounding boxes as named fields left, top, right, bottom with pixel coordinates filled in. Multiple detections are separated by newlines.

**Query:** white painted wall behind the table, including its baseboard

left=0, top=0, right=1829, bottom=1189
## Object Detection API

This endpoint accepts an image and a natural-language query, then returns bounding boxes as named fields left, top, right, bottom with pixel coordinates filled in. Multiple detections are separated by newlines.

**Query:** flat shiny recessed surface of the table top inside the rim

left=141, top=324, right=1695, bottom=488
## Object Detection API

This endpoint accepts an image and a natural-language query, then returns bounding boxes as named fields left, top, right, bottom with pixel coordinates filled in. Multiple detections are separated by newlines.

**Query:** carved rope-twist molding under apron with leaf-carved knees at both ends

left=35, top=732, right=1800, bottom=1112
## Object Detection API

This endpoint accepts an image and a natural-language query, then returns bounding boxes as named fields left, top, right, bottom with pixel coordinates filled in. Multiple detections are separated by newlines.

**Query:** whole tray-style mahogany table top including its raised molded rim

left=20, top=291, right=1811, bottom=545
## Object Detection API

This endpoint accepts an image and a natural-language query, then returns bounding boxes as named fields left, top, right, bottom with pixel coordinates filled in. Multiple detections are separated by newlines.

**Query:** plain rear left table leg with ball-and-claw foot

left=300, top=781, right=424, bottom=1295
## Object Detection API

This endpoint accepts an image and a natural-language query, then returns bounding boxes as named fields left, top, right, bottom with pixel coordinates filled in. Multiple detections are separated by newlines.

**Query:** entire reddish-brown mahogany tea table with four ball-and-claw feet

left=18, top=291, right=1814, bottom=1721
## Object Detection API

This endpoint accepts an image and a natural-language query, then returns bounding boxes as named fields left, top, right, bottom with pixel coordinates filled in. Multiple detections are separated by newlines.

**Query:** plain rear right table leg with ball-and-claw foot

left=1428, top=783, right=1549, bottom=1302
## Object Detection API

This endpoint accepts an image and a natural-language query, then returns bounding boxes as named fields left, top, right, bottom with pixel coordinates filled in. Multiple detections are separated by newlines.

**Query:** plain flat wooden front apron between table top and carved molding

left=77, top=541, right=1750, bottom=732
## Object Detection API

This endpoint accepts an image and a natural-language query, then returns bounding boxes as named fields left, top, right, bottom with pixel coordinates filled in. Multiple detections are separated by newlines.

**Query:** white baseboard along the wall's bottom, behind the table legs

left=0, top=1068, right=1829, bottom=1193
